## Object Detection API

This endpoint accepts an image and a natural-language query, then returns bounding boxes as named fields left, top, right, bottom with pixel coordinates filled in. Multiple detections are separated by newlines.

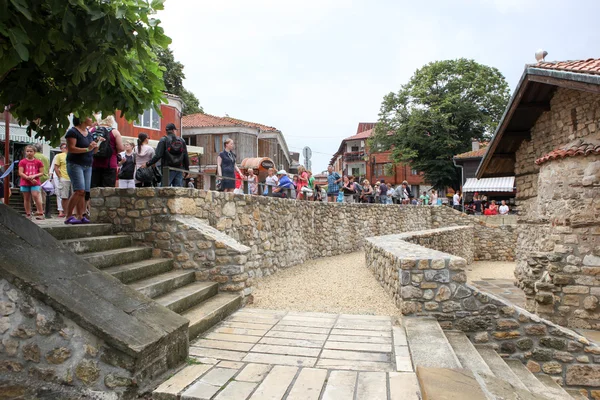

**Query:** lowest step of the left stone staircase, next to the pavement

left=181, top=293, right=242, bottom=339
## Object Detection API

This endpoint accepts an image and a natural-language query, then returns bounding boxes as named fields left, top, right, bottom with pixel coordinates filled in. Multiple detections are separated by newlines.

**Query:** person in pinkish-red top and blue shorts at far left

left=19, top=146, right=44, bottom=220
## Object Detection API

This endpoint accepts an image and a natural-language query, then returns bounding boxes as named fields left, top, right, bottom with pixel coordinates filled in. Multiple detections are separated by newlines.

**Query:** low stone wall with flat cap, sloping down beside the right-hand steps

left=365, top=228, right=600, bottom=396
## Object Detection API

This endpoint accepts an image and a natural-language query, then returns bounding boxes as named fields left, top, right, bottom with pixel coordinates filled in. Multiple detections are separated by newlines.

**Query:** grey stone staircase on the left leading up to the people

left=45, top=224, right=242, bottom=339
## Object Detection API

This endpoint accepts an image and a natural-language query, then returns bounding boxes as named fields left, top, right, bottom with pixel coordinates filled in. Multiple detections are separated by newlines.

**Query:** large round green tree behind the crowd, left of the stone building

left=371, top=59, right=509, bottom=189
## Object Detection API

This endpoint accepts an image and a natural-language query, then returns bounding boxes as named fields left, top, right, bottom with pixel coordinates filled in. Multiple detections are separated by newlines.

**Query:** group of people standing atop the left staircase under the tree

left=5, top=116, right=189, bottom=224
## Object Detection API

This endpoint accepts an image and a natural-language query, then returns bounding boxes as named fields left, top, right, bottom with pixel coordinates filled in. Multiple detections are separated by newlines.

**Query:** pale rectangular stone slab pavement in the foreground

left=154, top=308, right=419, bottom=400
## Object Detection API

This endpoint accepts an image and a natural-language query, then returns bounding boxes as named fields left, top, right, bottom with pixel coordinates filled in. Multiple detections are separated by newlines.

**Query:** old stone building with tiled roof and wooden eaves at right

left=477, top=59, right=600, bottom=330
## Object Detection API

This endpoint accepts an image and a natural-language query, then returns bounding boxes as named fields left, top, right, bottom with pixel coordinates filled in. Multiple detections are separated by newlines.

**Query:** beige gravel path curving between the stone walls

left=249, top=252, right=400, bottom=316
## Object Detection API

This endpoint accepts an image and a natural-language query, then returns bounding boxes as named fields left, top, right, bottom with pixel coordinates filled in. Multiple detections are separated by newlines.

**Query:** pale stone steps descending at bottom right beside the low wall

left=403, top=318, right=587, bottom=400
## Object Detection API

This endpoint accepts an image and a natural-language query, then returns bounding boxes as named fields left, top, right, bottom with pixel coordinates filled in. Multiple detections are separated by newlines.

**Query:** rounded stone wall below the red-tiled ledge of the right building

left=518, top=155, right=600, bottom=329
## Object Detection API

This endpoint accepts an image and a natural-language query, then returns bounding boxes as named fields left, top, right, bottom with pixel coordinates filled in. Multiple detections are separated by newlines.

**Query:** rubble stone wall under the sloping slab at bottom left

left=0, top=279, right=138, bottom=399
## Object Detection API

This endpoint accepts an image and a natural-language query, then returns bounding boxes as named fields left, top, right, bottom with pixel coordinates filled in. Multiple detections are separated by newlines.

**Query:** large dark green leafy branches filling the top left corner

left=0, top=0, right=171, bottom=142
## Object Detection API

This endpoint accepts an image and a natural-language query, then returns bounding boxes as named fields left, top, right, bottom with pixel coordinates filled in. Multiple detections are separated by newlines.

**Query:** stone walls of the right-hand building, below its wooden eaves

left=515, top=88, right=600, bottom=329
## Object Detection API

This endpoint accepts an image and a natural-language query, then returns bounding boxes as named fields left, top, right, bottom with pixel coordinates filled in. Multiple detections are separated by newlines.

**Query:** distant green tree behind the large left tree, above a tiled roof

left=156, top=49, right=204, bottom=115
